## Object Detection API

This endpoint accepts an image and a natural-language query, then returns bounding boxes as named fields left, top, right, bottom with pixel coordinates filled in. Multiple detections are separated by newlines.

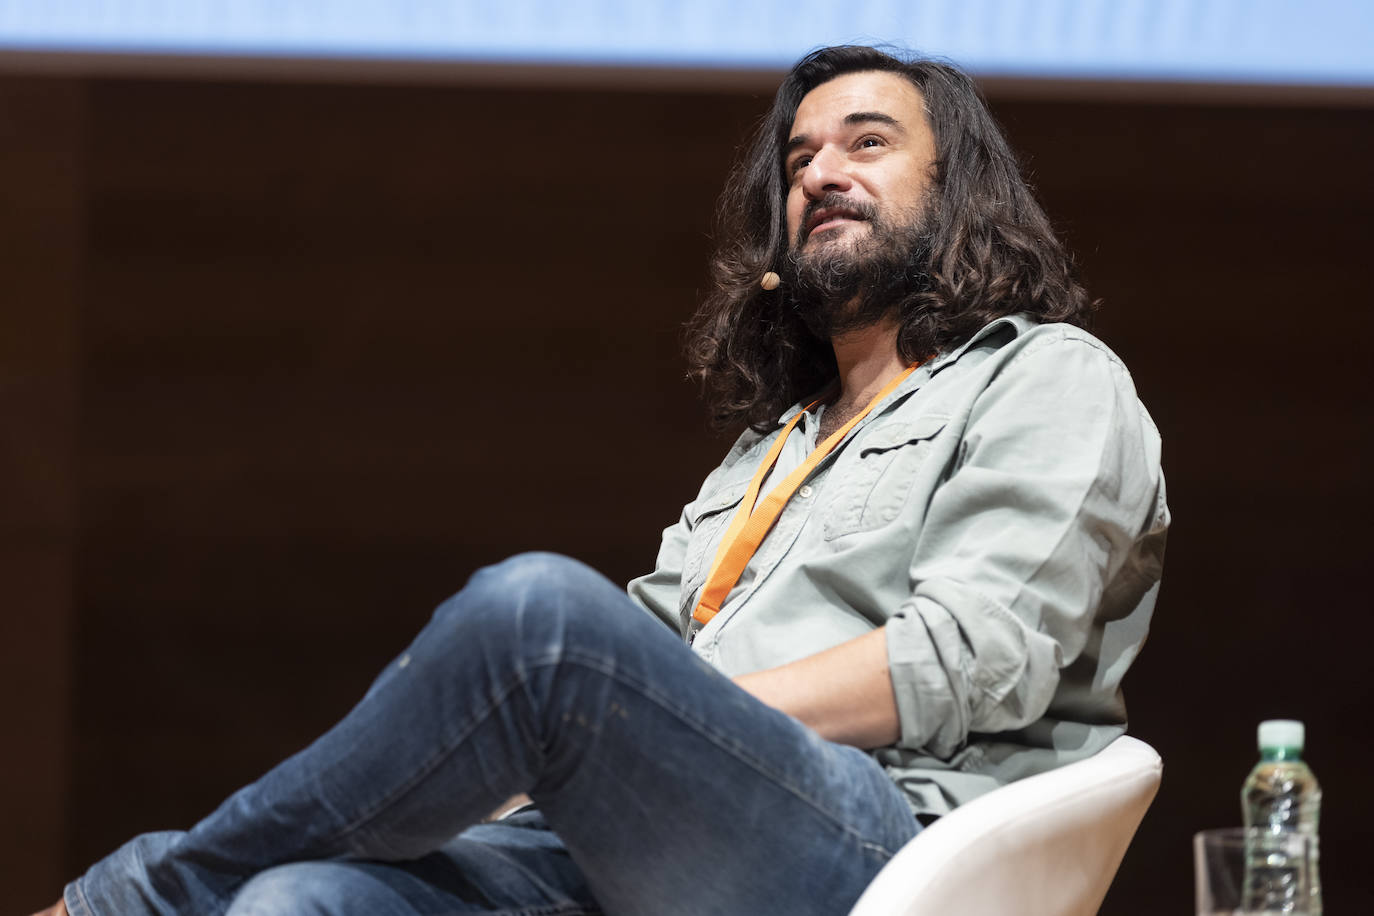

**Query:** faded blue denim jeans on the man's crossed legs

left=66, top=553, right=919, bottom=916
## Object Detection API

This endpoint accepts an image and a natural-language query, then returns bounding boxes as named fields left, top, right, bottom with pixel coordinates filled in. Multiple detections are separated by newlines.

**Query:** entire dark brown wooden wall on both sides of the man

left=0, top=77, right=1374, bottom=913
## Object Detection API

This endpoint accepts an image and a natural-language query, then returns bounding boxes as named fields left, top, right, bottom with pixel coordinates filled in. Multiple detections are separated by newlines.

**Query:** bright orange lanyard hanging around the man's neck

left=691, top=363, right=921, bottom=623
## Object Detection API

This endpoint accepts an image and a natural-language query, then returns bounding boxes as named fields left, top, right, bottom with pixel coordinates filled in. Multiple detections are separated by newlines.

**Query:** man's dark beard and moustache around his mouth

left=782, top=192, right=934, bottom=339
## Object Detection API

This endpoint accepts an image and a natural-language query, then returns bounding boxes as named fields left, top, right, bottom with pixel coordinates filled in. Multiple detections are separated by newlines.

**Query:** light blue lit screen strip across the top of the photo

left=0, top=0, right=1374, bottom=87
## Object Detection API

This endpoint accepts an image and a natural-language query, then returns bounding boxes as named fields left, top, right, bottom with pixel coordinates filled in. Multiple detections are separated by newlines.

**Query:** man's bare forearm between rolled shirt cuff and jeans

left=735, top=628, right=901, bottom=750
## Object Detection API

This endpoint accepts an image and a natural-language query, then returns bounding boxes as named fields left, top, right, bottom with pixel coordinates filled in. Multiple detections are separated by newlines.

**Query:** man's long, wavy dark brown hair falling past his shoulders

left=687, top=45, right=1095, bottom=431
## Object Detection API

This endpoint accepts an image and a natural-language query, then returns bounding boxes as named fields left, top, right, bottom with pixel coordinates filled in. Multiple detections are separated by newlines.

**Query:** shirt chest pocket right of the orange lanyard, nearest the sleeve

left=822, top=415, right=949, bottom=541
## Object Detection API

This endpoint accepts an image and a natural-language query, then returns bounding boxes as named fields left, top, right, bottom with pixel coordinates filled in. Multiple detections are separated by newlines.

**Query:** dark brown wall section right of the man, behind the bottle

left=996, top=96, right=1374, bottom=915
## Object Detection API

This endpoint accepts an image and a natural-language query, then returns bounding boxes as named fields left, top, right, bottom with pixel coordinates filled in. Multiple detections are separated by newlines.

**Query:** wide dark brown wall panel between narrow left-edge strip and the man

left=73, top=82, right=757, bottom=862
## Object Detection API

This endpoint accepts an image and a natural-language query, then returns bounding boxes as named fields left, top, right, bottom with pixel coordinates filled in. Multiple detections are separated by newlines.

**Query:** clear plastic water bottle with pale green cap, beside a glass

left=1241, top=718, right=1322, bottom=915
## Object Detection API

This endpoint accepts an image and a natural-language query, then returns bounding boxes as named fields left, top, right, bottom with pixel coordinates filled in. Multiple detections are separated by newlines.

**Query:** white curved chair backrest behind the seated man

left=849, top=735, right=1164, bottom=916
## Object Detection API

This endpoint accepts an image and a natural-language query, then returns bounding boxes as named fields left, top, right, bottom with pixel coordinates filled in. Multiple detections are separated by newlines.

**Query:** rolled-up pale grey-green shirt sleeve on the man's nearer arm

left=886, top=336, right=1161, bottom=758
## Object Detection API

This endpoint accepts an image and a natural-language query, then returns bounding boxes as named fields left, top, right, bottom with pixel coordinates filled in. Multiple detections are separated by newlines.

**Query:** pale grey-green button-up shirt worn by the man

left=629, top=317, right=1169, bottom=814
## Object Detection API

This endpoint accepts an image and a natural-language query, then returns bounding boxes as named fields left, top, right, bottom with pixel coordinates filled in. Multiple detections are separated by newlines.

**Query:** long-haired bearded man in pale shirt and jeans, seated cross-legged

left=37, top=48, right=1168, bottom=916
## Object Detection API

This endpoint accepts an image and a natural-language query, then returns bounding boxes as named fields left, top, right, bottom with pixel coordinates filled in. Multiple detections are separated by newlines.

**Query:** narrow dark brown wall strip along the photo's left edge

left=0, top=80, right=85, bottom=912
